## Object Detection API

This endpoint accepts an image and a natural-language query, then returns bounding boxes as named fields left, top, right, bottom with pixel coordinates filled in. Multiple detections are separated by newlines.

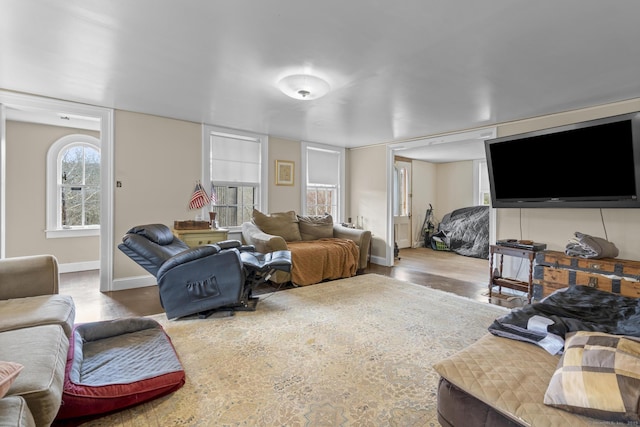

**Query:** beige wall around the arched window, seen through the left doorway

left=5, top=121, right=100, bottom=264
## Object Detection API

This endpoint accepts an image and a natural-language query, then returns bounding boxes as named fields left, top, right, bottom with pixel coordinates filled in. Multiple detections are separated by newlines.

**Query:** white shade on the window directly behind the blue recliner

left=211, top=134, right=260, bottom=183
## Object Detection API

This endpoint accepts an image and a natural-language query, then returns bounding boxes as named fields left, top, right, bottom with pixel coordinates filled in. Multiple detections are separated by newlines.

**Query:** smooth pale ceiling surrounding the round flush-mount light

left=0, top=0, right=640, bottom=162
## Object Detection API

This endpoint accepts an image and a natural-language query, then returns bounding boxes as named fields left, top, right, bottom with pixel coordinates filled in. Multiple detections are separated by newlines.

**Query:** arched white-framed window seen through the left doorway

left=47, top=134, right=100, bottom=238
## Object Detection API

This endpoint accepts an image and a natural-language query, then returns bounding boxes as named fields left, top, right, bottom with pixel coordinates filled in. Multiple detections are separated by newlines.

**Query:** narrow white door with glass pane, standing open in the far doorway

left=393, top=160, right=411, bottom=249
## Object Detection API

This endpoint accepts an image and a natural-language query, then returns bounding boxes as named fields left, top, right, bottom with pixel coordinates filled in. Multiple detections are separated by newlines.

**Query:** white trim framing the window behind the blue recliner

left=201, top=124, right=269, bottom=233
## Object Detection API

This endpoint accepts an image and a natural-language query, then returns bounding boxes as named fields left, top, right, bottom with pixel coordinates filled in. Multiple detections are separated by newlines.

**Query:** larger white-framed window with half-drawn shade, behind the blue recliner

left=203, top=126, right=268, bottom=229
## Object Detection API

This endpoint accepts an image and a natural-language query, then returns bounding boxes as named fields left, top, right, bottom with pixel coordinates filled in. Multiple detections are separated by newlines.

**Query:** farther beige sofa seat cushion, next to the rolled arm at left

left=0, top=294, right=76, bottom=338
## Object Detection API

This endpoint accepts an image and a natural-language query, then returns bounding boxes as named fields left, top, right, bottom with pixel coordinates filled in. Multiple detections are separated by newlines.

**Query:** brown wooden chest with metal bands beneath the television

left=533, top=251, right=640, bottom=300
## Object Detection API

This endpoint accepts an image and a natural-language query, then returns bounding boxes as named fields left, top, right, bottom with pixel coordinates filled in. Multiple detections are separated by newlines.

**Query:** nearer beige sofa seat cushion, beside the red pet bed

left=0, top=325, right=69, bottom=426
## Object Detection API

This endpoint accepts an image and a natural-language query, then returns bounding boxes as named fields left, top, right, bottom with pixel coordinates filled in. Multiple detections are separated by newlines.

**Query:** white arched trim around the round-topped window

left=45, top=134, right=102, bottom=239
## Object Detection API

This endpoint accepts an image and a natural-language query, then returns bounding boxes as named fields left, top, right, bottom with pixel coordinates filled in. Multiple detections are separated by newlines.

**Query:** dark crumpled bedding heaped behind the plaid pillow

left=489, top=286, right=640, bottom=352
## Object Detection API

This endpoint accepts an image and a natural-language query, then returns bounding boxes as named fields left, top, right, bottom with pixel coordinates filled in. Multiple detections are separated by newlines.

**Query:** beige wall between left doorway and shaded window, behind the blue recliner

left=113, top=111, right=201, bottom=279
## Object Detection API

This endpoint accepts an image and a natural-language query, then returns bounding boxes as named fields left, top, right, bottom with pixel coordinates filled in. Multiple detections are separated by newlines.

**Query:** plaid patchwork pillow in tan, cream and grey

left=544, top=331, right=640, bottom=422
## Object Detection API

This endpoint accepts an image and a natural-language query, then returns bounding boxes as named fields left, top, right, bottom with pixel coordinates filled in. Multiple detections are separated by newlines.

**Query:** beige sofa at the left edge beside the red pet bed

left=0, top=255, right=75, bottom=426
